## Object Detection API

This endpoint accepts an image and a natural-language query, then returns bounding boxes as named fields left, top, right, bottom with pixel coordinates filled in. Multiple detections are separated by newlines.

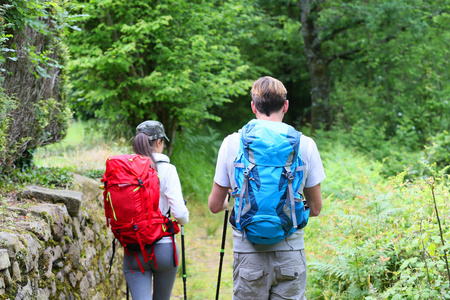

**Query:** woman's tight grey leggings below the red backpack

left=123, top=241, right=179, bottom=300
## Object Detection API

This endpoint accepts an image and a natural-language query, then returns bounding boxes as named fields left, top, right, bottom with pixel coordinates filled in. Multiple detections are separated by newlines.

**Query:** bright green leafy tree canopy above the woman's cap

left=68, top=0, right=258, bottom=137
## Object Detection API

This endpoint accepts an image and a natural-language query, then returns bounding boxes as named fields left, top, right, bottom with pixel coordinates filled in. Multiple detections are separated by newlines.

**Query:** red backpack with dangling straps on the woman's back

left=102, top=154, right=180, bottom=272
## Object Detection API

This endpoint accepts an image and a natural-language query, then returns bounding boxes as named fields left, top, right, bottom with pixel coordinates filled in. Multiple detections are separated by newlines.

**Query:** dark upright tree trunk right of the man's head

left=298, top=0, right=331, bottom=131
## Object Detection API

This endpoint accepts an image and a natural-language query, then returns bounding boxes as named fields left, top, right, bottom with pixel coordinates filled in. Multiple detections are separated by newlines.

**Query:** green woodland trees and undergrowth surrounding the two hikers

left=0, top=0, right=450, bottom=299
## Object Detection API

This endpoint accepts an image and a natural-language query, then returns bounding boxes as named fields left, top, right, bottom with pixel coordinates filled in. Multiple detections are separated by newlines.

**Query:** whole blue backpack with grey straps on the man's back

left=231, top=120, right=309, bottom=245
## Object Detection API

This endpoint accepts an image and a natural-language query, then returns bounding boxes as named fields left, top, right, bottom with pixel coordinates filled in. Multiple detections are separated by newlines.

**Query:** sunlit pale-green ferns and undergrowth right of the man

left=305, top=138, right=450, bottom=300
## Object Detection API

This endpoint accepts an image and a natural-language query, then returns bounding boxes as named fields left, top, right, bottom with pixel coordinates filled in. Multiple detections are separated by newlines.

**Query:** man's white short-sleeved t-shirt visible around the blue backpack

left=214, top=125, right=325, bottom=252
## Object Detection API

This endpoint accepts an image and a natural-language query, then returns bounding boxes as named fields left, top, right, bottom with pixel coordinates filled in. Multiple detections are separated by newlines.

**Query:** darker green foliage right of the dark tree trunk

left=319, top=0, right=450, bottom=161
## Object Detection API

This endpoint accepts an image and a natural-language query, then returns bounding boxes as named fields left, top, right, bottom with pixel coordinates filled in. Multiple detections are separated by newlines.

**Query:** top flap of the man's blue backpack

left=240, top=119, right=300, bottom=167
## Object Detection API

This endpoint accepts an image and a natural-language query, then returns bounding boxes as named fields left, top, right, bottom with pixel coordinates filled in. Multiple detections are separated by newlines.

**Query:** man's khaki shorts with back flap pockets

left=233, top=250, right=306, bottom=300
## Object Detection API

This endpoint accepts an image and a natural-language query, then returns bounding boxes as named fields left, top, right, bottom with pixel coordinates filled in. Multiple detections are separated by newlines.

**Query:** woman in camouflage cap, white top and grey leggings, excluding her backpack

left=123, top=121, right=189, bottom=300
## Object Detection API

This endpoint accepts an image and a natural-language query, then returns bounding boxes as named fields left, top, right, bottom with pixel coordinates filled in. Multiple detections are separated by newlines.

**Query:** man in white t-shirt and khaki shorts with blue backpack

left=208, top=76, right=325, bottom=300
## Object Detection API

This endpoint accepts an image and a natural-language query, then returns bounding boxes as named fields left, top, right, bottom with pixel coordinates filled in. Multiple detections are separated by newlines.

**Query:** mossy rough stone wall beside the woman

left=0, top=175, right=125, bottom=300
